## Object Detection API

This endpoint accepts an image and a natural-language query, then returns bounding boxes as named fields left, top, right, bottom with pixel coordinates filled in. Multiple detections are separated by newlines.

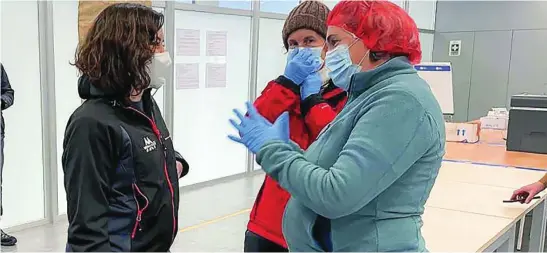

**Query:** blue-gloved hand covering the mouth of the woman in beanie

left=283, top=48, right=322, bottom=85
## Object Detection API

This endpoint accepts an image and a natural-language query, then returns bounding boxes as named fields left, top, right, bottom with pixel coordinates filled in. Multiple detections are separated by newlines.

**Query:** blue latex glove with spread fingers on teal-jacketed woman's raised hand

left=228, top=102, right=289, bottom=154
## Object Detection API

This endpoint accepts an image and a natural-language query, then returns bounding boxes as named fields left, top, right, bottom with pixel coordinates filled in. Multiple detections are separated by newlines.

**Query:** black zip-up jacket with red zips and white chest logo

left=62, top=76, right=188, bottom=252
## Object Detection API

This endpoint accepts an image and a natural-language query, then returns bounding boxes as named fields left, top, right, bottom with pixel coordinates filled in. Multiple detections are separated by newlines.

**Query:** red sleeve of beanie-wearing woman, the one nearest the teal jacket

left=300, top=94, right=337, bottom=140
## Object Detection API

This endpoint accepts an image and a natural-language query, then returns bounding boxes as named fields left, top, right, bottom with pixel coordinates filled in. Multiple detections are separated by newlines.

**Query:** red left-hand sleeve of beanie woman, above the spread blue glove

left=254, top=76, right=300, bottom=122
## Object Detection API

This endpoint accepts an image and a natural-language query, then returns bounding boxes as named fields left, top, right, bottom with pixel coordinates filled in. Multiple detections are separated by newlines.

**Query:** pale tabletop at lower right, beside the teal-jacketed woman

left=423, top=162, right=547, bottom=252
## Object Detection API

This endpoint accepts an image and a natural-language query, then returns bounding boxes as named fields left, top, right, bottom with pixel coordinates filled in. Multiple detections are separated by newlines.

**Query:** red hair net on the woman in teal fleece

left=327, top=0, right=422, bottom=64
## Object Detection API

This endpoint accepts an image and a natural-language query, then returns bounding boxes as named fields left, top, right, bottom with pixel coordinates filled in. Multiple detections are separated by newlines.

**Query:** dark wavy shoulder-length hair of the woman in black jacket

left=74, top=3, right=164, bottom=99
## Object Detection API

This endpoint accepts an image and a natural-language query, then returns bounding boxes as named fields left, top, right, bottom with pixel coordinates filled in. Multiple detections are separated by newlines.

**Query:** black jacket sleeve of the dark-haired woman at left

left=62, top=115, right=118, bottom=252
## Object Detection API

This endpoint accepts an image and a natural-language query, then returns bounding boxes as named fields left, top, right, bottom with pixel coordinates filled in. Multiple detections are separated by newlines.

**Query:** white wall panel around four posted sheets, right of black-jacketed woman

left=172, top=11, right=251, bottom=185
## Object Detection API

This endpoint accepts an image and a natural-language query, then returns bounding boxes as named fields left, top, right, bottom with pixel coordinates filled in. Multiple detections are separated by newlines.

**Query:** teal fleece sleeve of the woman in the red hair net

left=257, top=92, right=442, bottom=219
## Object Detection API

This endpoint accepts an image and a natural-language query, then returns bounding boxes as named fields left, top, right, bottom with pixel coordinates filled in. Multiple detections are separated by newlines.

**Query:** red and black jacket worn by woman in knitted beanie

left=247, top=76, right=347, bottom=248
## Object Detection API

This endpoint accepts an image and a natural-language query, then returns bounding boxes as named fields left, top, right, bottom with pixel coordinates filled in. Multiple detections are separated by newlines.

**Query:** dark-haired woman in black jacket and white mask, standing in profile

left=62, top=3, right=188, bottom=252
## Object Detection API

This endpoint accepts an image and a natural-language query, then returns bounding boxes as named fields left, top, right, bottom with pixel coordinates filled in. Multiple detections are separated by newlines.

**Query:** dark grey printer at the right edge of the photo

left=507, top=94, right=547, bottom=154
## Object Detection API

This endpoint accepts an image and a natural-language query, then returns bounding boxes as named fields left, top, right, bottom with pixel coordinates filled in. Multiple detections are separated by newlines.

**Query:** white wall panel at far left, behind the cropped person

left=0, top=1, right=44, bottom=227
